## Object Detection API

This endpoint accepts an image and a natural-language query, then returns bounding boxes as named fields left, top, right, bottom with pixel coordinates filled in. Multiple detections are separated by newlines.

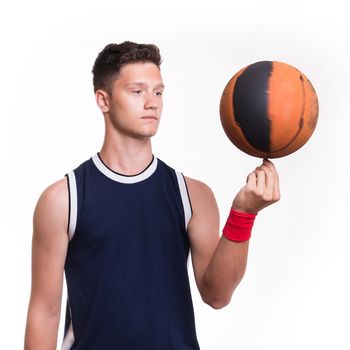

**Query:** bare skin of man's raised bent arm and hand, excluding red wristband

left=186, top=160, right=280, bottom=309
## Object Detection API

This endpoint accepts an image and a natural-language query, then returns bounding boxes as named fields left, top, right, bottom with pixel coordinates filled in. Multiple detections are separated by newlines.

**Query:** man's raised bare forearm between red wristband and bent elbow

left=201, top=236, right=249, bottom=309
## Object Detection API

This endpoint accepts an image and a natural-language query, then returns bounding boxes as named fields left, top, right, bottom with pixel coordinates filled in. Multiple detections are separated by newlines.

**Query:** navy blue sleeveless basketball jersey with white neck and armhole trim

left=62, top=153, right=199, bottom=350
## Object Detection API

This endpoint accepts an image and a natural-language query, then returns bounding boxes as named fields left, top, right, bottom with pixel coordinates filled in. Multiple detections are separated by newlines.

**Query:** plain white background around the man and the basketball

left=0, top=0, right=350, bottom=350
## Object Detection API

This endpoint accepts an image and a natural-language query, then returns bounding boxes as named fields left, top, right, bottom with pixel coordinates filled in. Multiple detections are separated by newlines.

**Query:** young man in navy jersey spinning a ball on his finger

left=25, top=42, right=280, bottom=350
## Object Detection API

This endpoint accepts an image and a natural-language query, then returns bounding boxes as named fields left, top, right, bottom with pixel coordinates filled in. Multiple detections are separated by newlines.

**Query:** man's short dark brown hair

left=92, top=41, right=162, bottom=93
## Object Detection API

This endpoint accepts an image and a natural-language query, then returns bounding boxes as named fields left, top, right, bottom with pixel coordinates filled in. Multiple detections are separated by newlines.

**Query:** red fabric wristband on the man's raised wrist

left=222, top=209, right=257, bottom=242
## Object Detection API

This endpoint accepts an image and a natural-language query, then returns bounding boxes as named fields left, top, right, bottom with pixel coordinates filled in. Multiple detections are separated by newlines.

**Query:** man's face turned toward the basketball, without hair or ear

left=107, top=62, right=164, bottom=139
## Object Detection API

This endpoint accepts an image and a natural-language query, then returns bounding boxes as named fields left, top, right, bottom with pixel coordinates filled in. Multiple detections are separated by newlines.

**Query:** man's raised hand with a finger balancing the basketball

left=232, top=159, right=280, bottom=213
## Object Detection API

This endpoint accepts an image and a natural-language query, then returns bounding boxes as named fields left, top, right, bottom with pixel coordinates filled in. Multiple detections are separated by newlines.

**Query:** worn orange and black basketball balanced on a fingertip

left=220, top=61, right=318, bottom=158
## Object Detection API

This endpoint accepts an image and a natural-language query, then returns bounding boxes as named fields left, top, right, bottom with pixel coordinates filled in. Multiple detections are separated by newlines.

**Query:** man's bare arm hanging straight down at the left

left=24, top=178, right=69, bottom=350
